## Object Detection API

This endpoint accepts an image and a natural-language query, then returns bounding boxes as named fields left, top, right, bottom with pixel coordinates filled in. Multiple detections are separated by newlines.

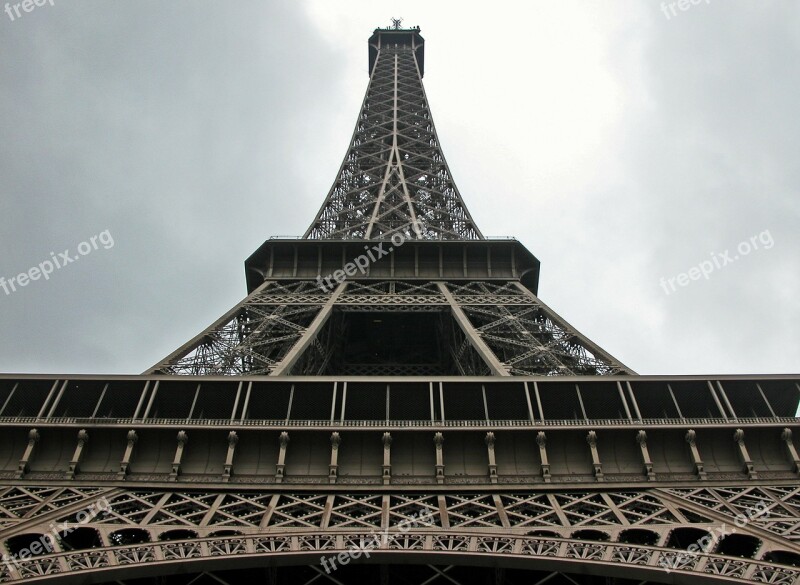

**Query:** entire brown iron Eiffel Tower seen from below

left=0, top=21, right=800, bottom=585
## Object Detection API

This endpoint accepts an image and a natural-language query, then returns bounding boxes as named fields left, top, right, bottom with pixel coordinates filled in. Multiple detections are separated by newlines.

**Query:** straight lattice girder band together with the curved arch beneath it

left=0, top=484, right=800, bottom=585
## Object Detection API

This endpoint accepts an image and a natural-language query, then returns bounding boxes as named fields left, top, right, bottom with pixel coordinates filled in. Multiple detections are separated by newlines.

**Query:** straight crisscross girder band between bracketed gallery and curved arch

left=0, top=486, right=800, bottom=541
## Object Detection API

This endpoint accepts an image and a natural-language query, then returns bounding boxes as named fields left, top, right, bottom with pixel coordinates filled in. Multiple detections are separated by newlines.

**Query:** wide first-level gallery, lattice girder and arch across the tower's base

left=0, top=375, right=800, bottom=585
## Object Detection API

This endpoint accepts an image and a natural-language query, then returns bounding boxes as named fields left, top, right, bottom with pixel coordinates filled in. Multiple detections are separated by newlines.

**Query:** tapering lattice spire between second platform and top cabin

left=304, top=45, right=483, bottom=240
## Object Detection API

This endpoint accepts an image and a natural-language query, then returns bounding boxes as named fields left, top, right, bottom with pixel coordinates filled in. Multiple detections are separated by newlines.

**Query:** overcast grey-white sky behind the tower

left=0, top=0, right=800, bottom=374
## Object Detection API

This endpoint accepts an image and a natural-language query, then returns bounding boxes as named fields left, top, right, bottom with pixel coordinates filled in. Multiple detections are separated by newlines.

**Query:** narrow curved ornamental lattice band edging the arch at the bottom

left=0, top=528, right=800, bottom=585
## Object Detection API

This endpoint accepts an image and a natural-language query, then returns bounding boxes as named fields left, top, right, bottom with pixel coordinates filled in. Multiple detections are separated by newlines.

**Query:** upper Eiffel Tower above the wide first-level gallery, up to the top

left=142, top=29, right=631, bottom=375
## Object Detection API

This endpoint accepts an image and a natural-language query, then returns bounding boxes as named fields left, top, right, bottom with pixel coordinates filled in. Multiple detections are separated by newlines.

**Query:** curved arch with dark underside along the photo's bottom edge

left=0, top=530, right=800, bottom=585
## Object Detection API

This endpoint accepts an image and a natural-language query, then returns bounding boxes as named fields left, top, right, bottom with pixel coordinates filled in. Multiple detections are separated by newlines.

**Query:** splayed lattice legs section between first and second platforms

left=148, top=280, right=629, bottom=375
